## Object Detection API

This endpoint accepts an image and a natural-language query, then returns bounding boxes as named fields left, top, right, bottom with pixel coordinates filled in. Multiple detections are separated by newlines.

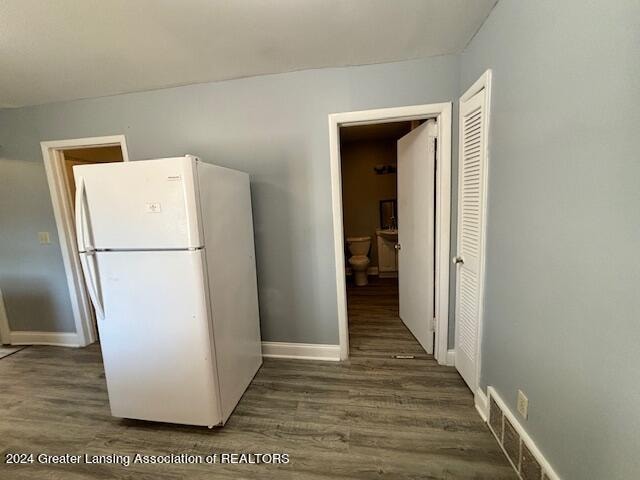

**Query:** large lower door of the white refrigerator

left=95, top=250, right=221, bottom=426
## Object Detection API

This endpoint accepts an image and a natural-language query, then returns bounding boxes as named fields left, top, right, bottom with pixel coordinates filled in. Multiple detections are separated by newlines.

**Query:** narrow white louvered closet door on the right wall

left=454, top=90, right=487, bottom=393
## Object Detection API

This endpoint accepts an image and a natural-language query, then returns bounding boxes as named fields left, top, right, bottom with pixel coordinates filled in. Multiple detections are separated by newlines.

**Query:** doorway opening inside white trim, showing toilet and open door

left=340, top=119, right=435, bottom=358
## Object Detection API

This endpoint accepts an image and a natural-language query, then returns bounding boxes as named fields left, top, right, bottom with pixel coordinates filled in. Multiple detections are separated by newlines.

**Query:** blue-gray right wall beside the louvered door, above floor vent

left=460, top=0, right=640, bottom=480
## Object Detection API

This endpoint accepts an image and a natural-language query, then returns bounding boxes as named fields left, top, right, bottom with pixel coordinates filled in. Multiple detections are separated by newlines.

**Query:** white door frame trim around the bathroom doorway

left=329, top=102, right=452, bottom=364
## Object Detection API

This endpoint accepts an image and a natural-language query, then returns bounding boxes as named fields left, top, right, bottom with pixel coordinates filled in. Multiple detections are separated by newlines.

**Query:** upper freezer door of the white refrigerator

left=73, top=156, right=203, bottom=250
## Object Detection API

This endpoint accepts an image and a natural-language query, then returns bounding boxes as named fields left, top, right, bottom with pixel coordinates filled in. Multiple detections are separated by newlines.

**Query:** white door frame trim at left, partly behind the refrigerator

left=40, top=135, right=129, bottom=347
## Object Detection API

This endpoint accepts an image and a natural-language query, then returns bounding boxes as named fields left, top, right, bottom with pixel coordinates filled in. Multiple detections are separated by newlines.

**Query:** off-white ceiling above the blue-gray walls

left=0, top=0, right=497, bottom=107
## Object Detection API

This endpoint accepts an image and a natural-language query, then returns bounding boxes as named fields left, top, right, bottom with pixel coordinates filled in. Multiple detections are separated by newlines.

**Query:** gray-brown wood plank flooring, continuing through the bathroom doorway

left=0, top=280, right=516, bottom=480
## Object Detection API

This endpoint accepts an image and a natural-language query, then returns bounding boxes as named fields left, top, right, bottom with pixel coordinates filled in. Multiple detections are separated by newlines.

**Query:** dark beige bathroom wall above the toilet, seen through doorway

left=341, top=139, right=397, bottom=267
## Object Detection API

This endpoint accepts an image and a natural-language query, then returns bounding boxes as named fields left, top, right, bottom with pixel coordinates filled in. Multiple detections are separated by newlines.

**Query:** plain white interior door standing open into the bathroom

left=398, top=120, right=437, bottom=353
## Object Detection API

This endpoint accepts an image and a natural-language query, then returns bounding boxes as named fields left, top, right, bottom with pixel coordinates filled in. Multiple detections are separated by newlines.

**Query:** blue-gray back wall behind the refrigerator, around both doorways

left=0, top=56, right=459, bottom=344
